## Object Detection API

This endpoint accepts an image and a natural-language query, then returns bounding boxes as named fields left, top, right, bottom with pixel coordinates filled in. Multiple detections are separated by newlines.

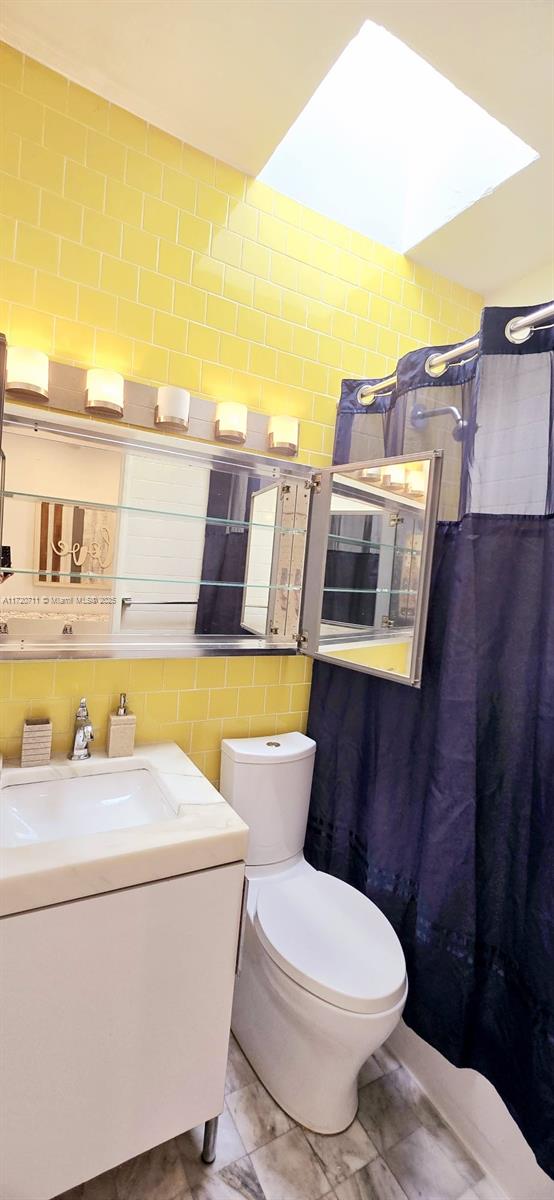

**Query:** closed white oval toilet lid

left=254, top=871, right=405, bottom=1013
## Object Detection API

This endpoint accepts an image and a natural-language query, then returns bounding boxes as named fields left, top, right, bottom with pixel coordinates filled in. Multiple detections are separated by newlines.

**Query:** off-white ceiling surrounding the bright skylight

left=0, top=0, right=554, bottom=294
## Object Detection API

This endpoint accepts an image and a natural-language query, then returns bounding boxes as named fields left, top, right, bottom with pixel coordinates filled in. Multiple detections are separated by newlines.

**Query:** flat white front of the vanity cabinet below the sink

left=0, top=863, right=243, bottom=1200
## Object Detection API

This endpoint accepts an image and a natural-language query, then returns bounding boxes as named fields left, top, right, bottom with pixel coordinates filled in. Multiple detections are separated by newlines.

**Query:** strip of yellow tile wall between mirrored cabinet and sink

left=0, top=655, right=312, bottom=784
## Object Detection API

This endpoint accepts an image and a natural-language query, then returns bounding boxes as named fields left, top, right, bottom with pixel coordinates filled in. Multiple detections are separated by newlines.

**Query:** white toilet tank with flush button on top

left=219, top=733, right=315, bottom=866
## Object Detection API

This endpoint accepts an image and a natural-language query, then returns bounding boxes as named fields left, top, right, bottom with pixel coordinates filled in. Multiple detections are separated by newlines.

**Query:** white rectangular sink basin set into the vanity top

left=0, top=768, right=175, bottom=848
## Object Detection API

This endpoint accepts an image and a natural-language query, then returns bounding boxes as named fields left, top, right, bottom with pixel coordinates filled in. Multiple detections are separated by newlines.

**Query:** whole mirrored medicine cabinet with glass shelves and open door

left=0, top=391, right=441, bottom=685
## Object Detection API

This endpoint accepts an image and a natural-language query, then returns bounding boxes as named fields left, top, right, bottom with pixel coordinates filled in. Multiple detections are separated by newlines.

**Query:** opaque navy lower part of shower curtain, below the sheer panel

left=306, top=515, right=554, bottom=1176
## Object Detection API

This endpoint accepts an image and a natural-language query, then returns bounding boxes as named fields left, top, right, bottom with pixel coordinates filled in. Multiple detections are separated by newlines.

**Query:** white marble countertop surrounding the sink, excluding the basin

left=0, top=743, right=248, bottom=916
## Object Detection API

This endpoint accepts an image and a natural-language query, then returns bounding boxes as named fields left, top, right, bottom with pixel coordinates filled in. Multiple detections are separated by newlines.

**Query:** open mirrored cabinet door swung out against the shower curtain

left=300, top=450, right=442, bottom=688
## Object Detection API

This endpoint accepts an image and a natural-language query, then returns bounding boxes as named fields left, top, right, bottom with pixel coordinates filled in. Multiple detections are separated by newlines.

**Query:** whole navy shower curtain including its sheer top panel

left=306, top=307, right=554, bottom=1177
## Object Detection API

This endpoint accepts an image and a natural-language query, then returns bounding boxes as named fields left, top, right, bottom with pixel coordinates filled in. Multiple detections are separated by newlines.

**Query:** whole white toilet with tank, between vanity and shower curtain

left=219, top=733, right=408, bottom=1134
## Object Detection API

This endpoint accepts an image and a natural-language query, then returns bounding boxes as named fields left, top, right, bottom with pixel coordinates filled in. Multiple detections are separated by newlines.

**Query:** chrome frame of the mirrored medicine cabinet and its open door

left=0, top=403, right=442, bottom=686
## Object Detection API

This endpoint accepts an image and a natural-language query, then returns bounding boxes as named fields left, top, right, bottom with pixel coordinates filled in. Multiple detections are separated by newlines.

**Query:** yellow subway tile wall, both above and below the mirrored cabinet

left=0, top=43, right=481, bottom=779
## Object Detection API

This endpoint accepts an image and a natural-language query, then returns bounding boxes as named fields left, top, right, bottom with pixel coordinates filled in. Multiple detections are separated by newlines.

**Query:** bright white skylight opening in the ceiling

left=259, top=20, right=538, bottom=252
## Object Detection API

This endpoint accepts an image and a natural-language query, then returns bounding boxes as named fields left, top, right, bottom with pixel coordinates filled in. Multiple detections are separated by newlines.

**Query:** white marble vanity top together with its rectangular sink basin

left=0, top=743, right=248, bottom=916
